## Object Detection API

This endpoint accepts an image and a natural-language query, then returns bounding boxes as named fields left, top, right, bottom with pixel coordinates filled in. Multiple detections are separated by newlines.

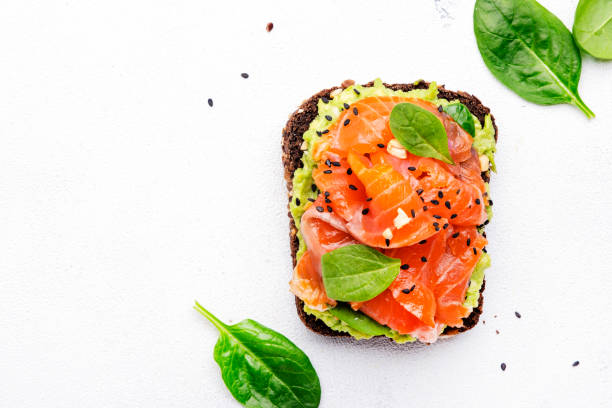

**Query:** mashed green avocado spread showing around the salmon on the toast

left=289, top=79, right=496, bottom=343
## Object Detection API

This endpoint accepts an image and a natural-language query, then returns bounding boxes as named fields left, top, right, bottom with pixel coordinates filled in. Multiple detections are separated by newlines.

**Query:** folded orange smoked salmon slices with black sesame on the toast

left=290, top=97, right=486, bottom=342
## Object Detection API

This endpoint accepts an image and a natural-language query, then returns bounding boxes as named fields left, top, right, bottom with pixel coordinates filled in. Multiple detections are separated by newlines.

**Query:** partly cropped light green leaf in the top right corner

left=573, top=0, right=612, bottom=60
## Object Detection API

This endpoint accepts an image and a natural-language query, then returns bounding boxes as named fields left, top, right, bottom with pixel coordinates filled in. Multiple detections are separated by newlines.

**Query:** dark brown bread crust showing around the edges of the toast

left=282, top=81, right=497, bottom=337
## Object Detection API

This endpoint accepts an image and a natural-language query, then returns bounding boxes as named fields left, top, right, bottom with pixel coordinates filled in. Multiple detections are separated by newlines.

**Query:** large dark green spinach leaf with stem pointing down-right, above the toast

left=474, top=0, right=595, bottom=118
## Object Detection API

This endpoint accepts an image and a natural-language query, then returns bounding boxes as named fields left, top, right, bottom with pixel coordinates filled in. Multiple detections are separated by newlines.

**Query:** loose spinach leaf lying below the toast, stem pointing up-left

left=194, top=302, right=321, bottom=408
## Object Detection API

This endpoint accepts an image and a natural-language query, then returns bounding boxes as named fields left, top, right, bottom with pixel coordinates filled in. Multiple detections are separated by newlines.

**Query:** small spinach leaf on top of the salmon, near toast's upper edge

left=389, top=103, right=453, bottom=164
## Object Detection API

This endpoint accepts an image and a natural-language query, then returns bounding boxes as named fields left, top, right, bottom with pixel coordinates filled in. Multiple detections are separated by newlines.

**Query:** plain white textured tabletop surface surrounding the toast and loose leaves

left=0, top=0, right=612, bottom=408
